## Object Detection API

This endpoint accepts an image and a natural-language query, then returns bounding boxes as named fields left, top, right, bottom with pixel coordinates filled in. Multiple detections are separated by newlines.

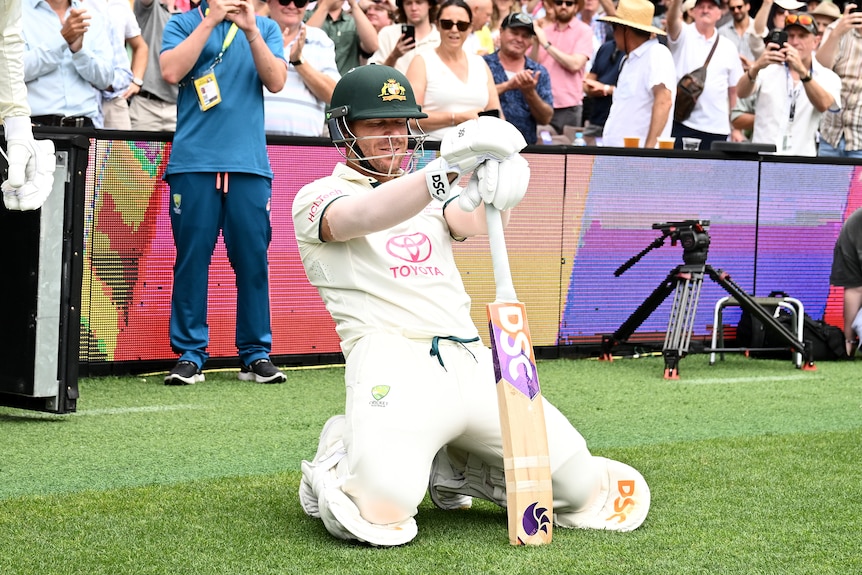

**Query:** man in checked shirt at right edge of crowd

left=816, top=2, right=862, bottom=158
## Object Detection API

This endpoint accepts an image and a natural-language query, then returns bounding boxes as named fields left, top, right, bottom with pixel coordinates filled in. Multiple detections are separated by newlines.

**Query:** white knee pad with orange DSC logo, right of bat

left=554, top=456, right=650, bottom=531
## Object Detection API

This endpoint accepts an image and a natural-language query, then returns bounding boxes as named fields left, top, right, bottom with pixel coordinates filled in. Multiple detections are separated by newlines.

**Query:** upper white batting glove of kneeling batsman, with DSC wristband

left=440, top=116, right=527, bottom=175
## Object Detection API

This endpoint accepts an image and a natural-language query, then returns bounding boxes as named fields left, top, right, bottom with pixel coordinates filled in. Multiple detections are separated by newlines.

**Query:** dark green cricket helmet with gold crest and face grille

left=326, top=64, right=428, bottom=177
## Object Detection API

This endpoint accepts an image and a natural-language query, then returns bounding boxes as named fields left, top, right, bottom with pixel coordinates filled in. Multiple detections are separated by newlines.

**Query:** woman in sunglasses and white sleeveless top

left=406, top=0, right=502, bottom=140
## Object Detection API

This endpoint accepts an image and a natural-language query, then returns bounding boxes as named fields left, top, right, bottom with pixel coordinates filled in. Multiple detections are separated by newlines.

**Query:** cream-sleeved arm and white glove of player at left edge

left=0, top=0, right=56, bottom=210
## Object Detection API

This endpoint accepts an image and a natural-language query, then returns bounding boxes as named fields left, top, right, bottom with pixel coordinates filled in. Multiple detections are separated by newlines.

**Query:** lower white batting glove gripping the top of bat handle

left=458, top=154, right=530, bottom=212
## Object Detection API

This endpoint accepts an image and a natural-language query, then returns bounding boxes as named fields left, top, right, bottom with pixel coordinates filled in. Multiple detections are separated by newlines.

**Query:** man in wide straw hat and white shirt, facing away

left=601, top=0, right=678, bottom=148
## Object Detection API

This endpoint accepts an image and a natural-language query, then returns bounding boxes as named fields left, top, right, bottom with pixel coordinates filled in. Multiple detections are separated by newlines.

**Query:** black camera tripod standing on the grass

left=601, top=220, right=816, bottom=379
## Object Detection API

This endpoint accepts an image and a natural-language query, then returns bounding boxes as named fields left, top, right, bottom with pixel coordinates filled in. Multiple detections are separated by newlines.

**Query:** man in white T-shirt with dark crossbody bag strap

left=667, top=0, right=743, bottom=150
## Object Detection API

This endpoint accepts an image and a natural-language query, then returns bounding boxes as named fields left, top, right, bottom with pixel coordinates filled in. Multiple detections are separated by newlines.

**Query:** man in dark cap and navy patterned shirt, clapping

left=484, top=12, right=554, bottom=144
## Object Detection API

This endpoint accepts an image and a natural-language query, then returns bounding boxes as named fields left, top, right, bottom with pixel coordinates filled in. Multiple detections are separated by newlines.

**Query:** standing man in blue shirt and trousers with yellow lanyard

left=164, top=0, right=287, bottom=385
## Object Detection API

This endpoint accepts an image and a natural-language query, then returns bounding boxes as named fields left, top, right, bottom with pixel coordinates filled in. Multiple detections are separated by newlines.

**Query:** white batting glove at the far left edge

left=0, top=140, right=57, bottom=211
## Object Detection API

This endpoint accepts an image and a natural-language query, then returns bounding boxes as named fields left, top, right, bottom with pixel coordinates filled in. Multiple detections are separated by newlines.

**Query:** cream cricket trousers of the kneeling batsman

left=334, top=334, right=595, bottom=517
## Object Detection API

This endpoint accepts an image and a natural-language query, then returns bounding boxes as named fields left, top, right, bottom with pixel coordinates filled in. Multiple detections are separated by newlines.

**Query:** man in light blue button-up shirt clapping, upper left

left=23, top=0, right=114, bottom=127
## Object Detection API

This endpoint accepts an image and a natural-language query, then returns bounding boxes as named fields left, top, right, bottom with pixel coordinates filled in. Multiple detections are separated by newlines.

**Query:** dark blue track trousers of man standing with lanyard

left=166, top=172, right=272, bottom=367
